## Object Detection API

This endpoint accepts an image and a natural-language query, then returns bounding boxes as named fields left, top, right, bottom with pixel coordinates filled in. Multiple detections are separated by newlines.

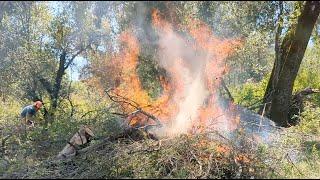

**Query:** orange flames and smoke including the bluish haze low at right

left=99, top=10, right=275, bottom=142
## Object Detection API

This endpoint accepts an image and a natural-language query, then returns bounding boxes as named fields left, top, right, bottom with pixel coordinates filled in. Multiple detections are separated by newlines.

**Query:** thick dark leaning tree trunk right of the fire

left=270, top=1, right=320, bottom=127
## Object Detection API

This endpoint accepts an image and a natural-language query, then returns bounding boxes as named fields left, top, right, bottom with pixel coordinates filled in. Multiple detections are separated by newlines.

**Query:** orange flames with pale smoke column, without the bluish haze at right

left=106, top=10, right=239, bottom=135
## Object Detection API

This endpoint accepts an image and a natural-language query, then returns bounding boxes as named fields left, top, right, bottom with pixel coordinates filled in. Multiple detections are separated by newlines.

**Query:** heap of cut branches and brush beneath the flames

left=4, top=132, right=270, bottom=178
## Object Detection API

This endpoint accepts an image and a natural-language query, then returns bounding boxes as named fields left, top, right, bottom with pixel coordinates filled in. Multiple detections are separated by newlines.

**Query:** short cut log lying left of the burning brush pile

left=57, top=126, right=94, bottom=159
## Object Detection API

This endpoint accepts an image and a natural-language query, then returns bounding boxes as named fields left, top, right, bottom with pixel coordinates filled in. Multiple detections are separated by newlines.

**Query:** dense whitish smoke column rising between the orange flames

left=153, top=22, right=208, bottom=134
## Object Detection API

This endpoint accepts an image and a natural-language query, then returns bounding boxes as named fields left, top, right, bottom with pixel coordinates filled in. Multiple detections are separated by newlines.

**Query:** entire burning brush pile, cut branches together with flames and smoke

left=1, top=10, right=284, bottom=178
